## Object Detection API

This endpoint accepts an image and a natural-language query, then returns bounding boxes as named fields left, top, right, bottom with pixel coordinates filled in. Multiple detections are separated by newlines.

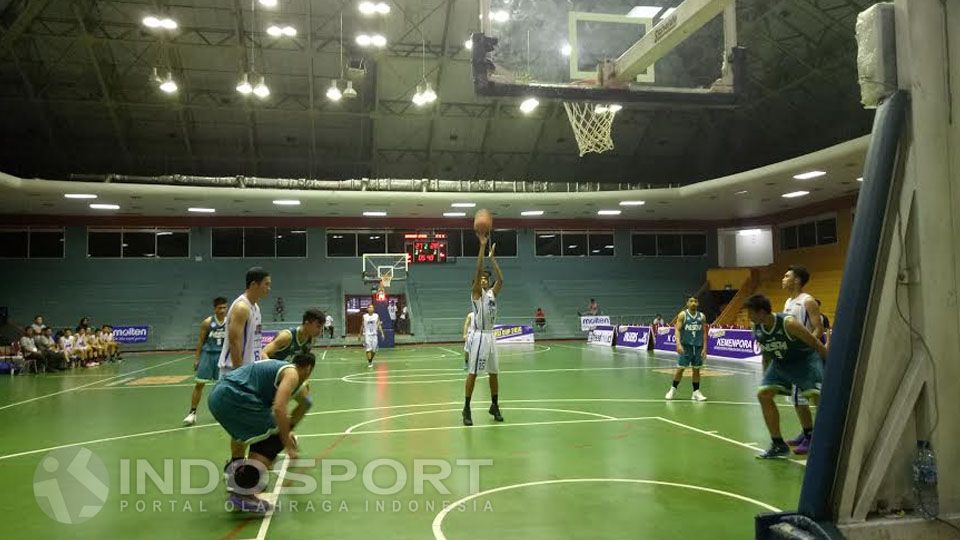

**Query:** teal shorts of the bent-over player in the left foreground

left=207, top=382, right=279, bottom=444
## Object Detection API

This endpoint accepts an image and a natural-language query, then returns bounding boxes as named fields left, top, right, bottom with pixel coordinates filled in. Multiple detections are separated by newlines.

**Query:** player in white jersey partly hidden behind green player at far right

left=780, top=266, right=823, bottom=455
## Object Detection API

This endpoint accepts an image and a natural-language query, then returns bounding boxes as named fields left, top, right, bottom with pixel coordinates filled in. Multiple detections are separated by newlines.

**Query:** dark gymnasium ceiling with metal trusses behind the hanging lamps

left=0, top=0, right=873, bottom=185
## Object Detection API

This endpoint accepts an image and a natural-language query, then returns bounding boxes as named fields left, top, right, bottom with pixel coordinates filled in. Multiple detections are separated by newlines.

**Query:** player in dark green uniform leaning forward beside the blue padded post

left=744, top=294, right=827, bottom=459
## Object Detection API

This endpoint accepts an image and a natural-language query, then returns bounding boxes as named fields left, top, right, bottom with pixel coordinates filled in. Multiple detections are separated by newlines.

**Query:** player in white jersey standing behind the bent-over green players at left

left=217, top=266, right=271, bottom=466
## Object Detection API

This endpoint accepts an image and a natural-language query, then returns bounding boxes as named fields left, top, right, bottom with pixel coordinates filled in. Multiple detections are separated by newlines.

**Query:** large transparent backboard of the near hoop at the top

left=471, top=0, right=743, bottom=107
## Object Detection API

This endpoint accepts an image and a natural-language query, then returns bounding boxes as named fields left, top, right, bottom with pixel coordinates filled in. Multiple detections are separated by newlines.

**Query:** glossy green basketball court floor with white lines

left=0, top=342, right=804, bottom=540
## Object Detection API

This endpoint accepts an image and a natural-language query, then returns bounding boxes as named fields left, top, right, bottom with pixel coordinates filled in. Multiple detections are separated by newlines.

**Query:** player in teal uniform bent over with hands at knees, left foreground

left=207, top=352, right=317, bottom=514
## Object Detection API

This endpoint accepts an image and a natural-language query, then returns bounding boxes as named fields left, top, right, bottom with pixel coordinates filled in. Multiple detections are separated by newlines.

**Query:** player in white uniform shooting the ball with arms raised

left=463, top=235, right=503, bottom=426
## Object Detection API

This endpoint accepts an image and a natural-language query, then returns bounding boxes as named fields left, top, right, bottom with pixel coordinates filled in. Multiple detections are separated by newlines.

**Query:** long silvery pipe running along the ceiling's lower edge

left=69, top=174, right=650, bottom=193
